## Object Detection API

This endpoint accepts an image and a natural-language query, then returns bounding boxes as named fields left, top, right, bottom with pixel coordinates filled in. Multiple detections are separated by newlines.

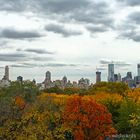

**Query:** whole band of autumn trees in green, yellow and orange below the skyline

left=0, top=81, right=140, bottom=140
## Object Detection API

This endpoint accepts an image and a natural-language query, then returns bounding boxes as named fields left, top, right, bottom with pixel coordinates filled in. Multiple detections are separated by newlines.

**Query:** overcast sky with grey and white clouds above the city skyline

left=0, top=0, right=140, bottom=82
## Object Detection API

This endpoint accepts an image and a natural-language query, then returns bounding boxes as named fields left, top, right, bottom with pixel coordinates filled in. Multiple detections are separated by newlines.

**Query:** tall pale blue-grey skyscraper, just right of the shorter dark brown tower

left=108, top=64, right=114, bottom=82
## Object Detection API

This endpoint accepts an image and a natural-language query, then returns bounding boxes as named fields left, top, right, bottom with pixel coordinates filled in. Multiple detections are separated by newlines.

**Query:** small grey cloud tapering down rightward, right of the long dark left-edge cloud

left=45, top=24, right=82, bottom=37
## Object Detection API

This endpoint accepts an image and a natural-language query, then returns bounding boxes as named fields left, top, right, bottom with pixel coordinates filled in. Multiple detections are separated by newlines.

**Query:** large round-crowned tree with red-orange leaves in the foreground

left=63, top=95, right=116, bottom=140
